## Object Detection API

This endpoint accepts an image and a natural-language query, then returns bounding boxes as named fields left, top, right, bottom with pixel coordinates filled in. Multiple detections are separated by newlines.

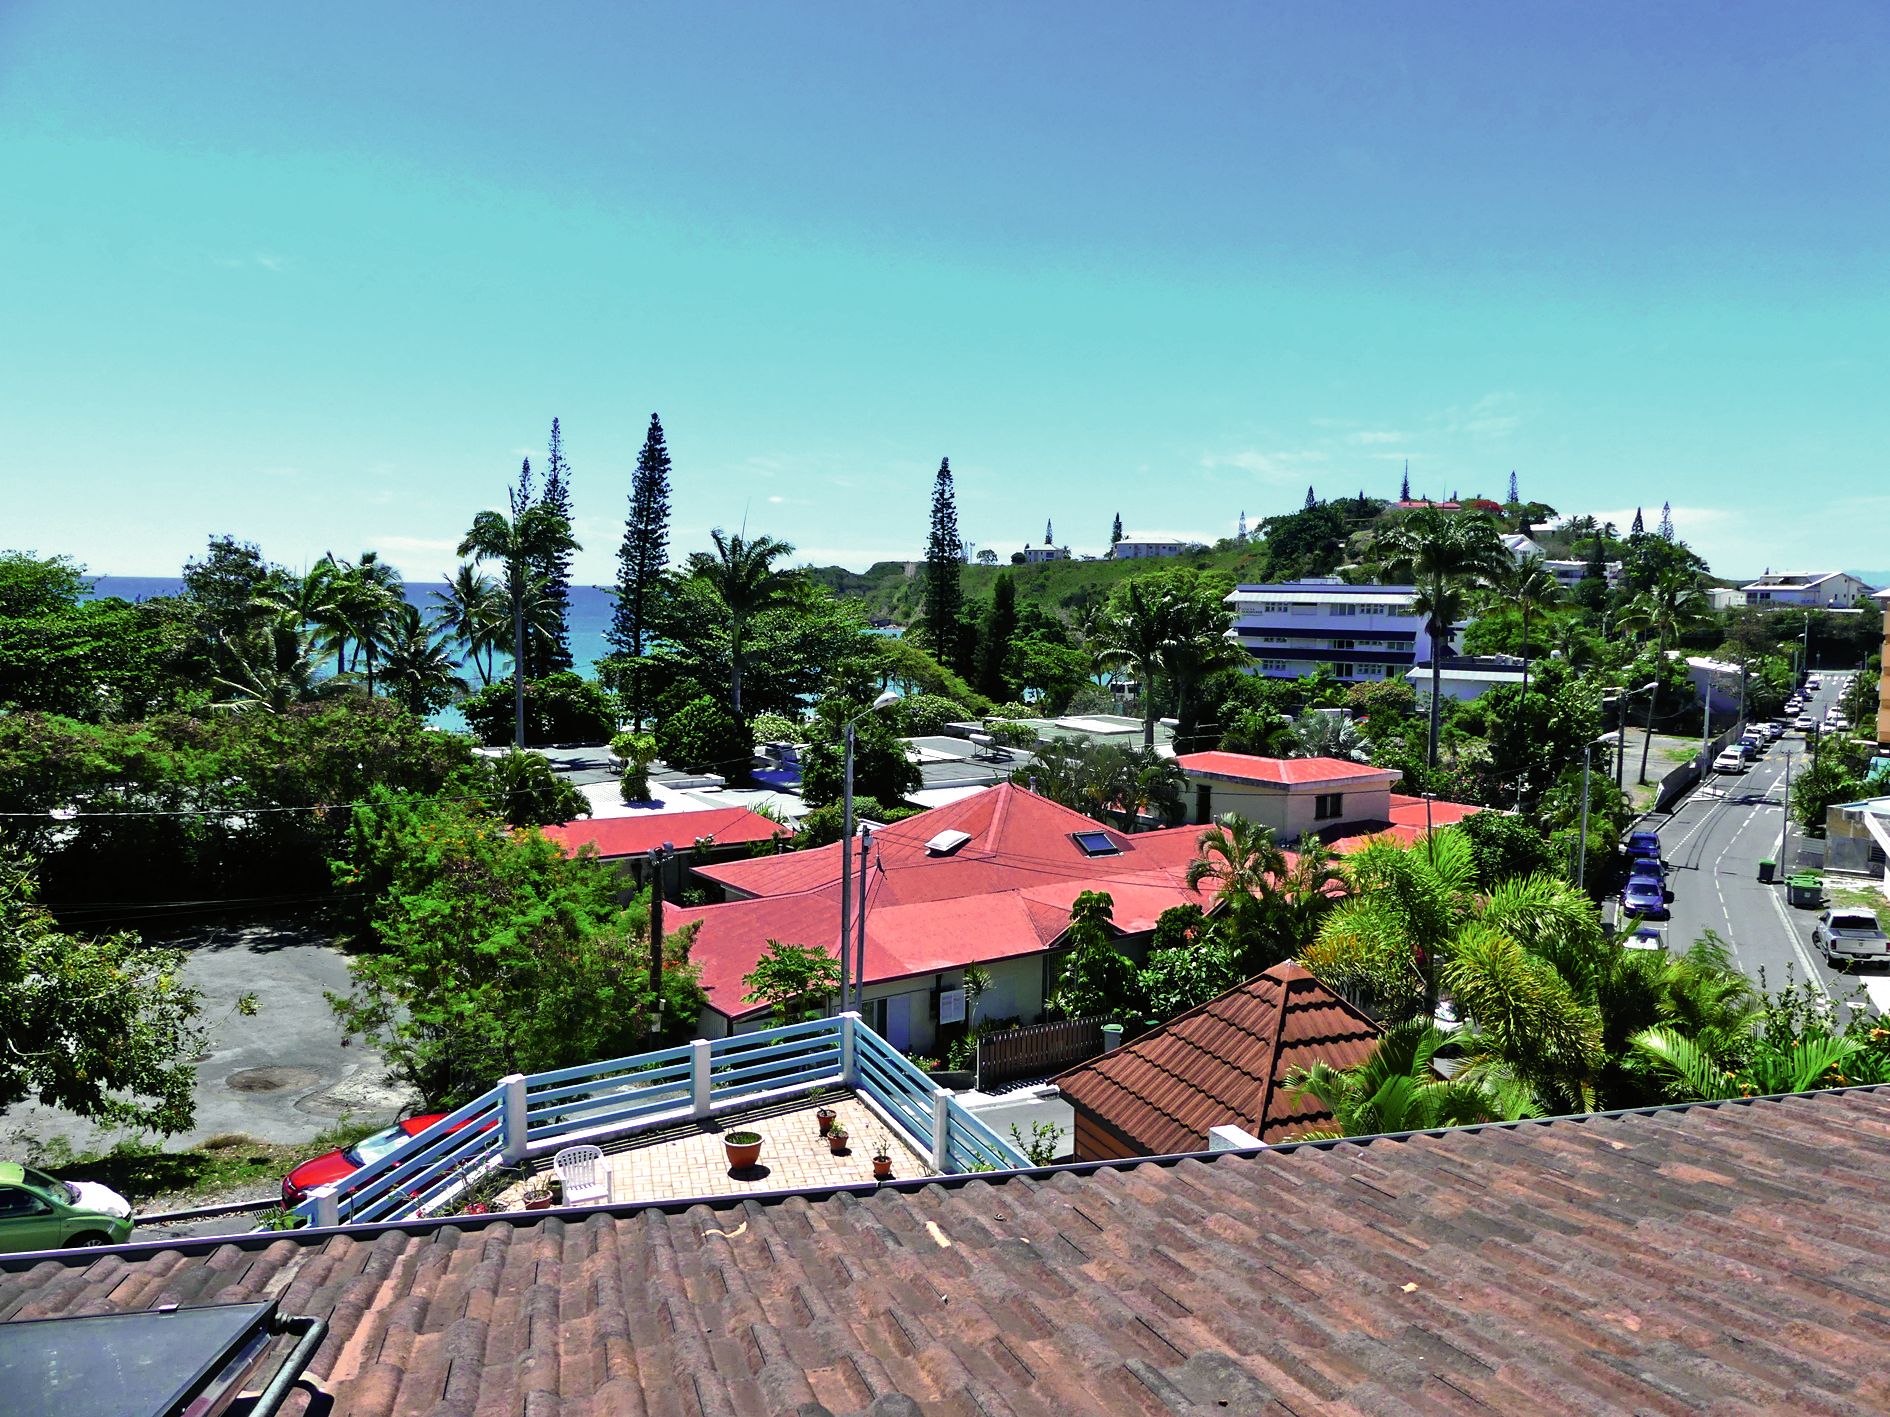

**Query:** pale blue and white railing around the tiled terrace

left=295, top=1013, right=1028, bottom=1226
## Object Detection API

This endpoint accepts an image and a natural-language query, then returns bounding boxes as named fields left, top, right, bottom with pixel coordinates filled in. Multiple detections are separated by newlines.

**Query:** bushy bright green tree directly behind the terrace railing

left=329, top=794, right=703, bottom=1107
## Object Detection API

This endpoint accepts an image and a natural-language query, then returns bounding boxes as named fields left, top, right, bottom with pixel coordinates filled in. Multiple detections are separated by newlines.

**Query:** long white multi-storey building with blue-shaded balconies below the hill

left=1227, top=580, right=1470, bottom=682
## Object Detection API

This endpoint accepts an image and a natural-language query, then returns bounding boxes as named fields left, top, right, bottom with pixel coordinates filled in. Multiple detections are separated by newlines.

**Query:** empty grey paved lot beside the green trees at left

left=0, top=924, right=408, bottom=1152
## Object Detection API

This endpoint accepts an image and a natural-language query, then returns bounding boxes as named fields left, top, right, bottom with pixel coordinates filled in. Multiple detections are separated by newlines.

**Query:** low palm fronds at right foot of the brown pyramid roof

left=1285, top=1018, right=1538, bottom=1141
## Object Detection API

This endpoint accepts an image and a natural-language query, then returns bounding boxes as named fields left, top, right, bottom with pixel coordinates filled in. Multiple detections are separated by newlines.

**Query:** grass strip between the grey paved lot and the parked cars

left=28, top=1117, right=380, bottom=1205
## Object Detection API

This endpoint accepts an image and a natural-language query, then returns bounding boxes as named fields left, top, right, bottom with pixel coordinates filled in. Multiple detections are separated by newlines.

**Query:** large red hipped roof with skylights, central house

left=667, top=782, right=1206, bottom=1018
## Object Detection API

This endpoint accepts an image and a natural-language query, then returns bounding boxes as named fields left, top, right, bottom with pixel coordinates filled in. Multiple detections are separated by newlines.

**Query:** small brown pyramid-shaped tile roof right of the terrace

left=1057, top=962, right=1378, bottom=1156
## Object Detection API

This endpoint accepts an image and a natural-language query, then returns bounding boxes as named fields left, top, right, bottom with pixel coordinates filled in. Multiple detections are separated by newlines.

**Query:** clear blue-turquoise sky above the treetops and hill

left=0, top=0, right=1890, bottom=584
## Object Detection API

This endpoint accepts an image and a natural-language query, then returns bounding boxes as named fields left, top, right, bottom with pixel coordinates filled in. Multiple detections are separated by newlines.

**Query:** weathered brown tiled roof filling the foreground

left=11, top=1090, right=1890, bottom=1417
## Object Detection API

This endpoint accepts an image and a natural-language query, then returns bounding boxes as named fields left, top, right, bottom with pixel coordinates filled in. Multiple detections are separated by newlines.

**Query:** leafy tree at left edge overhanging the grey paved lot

left=0, top=852, right=215, bottom=1135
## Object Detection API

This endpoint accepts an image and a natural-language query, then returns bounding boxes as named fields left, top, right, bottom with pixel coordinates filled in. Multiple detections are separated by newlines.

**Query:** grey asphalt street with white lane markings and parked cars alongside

left=1654, top=674, right=1867, bottom=1013
